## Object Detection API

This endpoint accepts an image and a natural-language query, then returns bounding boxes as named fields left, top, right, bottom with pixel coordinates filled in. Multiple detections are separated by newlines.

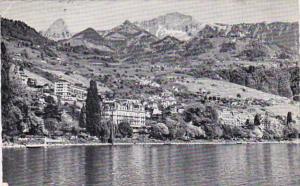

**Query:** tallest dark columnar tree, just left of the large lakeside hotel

left=86, top=80, right=101, bottom=136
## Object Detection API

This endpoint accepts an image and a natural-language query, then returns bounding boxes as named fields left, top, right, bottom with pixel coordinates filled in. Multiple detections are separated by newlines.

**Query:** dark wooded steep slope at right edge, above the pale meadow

left=194, top=66, right=300, bottom=100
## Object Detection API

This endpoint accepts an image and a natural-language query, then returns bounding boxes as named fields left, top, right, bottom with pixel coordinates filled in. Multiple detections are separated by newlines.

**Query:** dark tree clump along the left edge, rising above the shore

left=1, top=43, right=42, bottom=136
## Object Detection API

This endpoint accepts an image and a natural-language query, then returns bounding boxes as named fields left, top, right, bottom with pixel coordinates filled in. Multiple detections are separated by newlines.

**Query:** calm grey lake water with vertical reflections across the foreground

left=3, top=144, right=300, bottom=186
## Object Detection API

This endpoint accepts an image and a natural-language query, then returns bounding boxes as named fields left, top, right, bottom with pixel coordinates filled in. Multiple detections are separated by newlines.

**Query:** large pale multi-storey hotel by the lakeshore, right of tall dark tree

left=103, top=99, right=146, bottom=132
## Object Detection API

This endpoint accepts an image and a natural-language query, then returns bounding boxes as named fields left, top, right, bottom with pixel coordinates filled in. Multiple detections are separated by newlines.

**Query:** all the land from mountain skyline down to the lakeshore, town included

left=1, top=13, right=300, bottom=145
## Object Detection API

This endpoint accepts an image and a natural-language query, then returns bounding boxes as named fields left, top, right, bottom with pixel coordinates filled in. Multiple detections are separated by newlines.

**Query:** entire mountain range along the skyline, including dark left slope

left=1, top=12, right=299, bottom=61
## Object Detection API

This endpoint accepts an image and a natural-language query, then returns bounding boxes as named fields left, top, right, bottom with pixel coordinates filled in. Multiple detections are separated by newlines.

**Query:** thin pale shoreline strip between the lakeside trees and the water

left=1, top=139, right=300, bottom=149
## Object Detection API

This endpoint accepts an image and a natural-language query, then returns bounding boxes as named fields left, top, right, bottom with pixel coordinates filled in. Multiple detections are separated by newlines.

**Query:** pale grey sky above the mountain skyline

left=0, top=0, right=299, bottom=32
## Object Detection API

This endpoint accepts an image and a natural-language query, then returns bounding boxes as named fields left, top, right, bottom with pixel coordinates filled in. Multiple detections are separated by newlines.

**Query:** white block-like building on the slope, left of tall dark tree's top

left=54, top=79, right=87, bottom=101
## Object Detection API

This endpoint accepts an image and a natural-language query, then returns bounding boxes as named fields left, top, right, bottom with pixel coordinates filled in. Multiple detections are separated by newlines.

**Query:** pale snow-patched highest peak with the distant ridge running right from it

left=135, top=12, right=299, bottom=49
